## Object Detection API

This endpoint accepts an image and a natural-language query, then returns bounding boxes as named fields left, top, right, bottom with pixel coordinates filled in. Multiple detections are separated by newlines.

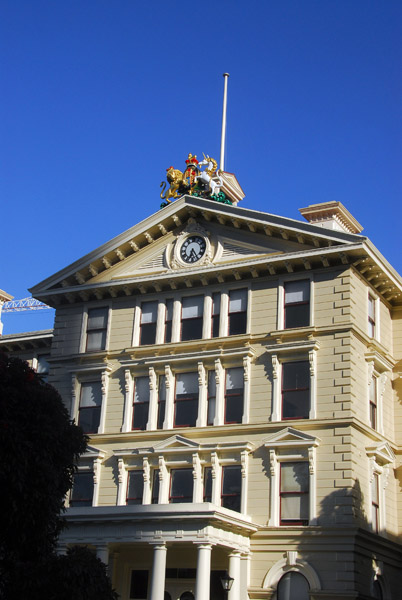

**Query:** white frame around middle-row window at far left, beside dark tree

left=70, top=365, right=112, bottom=435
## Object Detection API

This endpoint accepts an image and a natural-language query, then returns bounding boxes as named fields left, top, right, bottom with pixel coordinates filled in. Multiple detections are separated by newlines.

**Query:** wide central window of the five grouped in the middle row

left=174, top=373, right=198, bottom=427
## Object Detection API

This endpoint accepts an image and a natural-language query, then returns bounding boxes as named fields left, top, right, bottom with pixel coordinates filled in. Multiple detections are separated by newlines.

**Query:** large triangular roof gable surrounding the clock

left=31, top=196, right=370, bottom=306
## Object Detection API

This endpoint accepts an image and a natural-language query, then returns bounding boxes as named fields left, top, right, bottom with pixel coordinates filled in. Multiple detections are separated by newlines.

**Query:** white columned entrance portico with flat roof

left=60, top=503, right=257, bottom=600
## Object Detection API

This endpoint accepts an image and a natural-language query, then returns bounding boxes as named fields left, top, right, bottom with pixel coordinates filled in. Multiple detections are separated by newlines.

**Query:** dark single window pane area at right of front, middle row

left=282, top=361, right=310, bottom=419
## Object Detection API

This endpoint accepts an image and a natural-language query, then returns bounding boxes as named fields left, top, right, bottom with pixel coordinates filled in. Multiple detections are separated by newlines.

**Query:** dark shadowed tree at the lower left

left=0, top=352, right=115, bottom=600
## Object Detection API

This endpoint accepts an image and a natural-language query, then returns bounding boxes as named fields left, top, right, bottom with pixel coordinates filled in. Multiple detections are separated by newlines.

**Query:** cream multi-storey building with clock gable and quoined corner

left=0, top=196, right=402, bottom=600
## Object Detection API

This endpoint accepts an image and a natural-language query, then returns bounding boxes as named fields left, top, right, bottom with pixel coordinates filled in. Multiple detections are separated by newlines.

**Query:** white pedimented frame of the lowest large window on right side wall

left=366, top=442, right=395, bottom=535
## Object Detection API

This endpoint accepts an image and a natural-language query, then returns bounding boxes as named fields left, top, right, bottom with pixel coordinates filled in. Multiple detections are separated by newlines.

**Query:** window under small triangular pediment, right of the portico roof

left=280, top=462, right=309, bottom=525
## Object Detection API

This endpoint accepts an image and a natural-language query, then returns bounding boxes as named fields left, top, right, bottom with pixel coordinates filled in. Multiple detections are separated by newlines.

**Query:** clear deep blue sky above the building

left=0, top=0, right=402, bottom=334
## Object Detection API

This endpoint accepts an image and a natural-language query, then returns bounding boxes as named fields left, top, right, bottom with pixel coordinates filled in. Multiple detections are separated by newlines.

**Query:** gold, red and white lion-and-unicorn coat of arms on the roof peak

left=160, top=154, right=231, bottom=208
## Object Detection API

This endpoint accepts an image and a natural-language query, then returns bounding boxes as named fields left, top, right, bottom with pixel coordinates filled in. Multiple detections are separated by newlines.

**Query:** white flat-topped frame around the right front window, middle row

left=267, top=342, right=319, bottom=422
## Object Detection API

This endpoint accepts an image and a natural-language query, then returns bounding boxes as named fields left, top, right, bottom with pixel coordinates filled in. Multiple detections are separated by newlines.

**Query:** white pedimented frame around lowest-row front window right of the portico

left=263, top=427, right=319, bottom=527
